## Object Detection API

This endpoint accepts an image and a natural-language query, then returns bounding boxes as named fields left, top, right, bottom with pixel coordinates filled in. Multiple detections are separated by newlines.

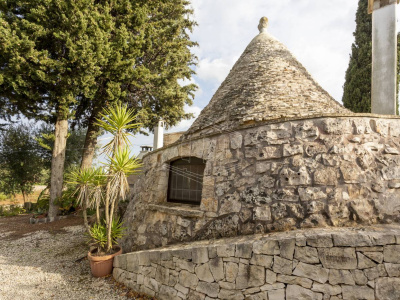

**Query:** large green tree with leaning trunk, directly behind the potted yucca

left=76, top=0, right=196, bottom=167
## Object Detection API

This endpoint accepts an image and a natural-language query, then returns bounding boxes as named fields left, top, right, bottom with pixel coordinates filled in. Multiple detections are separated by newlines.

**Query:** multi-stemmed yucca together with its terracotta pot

left=83, top=104, right=141, bottom=277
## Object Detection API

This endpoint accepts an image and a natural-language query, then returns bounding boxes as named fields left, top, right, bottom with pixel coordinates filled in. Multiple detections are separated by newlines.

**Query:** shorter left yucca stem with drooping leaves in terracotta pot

left=67, top=168, right=94, bottom=230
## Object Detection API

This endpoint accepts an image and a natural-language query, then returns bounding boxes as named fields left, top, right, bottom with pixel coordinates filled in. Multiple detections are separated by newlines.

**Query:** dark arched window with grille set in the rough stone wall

left=168, top=157, right=206, bottom=204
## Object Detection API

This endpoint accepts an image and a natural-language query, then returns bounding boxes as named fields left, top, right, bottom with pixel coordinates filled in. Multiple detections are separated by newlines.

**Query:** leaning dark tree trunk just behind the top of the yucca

left=81, top=107, right=100, bottom=169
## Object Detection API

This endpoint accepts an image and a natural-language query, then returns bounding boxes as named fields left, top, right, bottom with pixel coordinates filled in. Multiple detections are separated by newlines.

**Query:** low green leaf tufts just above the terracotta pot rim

left=89, top=218, right=126, bottom=252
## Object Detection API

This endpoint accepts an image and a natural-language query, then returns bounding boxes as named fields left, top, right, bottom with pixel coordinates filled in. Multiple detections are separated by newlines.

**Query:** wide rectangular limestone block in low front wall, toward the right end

left=318, top=247, right=357, bottom=270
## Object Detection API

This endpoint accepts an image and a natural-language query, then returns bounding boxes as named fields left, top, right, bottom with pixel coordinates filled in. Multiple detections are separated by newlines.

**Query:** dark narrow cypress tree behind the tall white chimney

left=342, top=0, right=400, bottom=113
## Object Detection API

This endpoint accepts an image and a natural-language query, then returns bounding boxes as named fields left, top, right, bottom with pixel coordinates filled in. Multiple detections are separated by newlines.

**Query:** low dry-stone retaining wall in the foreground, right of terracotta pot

left=113, top=225, right=400, bottom=300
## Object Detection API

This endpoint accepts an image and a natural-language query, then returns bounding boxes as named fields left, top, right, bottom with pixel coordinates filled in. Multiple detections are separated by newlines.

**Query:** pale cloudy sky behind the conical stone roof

left=97, top=0, right=399, bottom=162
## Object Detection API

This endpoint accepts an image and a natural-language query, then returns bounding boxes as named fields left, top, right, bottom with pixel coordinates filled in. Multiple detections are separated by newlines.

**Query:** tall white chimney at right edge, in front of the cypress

left=368, top=0, right=398, bottom=115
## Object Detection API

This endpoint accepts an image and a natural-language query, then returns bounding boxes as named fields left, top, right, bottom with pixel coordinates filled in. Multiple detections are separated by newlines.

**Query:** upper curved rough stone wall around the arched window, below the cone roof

left=122, top=116, right=400, bottom=251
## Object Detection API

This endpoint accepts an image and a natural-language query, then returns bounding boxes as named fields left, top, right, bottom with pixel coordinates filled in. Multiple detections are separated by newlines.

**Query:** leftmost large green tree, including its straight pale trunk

left=0, top=0, right=108, bottom=217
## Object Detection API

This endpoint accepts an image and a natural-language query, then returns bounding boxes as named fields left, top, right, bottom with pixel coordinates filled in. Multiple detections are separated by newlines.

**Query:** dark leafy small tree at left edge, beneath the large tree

left=0, top=124, right=44, bottom=195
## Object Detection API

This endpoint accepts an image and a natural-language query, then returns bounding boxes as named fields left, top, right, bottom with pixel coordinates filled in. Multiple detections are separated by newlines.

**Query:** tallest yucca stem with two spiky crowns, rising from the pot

left=97, top=104, right=140, bottom=252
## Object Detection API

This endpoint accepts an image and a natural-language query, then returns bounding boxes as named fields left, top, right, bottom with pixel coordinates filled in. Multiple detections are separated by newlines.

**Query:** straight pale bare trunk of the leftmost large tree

left=48, top=117, right=68, bottom=217
